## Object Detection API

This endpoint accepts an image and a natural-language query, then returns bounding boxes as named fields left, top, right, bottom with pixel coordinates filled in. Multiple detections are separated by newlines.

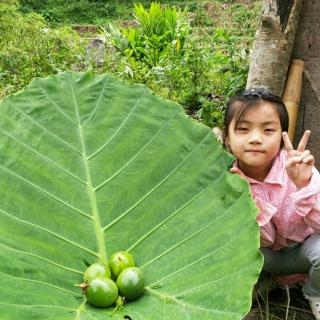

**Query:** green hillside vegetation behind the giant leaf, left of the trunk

left=0, top=0, right=260, bottom=127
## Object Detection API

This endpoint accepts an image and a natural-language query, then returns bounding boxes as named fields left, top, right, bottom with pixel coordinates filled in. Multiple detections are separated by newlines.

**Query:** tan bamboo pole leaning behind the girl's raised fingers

left=283, top=59, right=304, bottom=141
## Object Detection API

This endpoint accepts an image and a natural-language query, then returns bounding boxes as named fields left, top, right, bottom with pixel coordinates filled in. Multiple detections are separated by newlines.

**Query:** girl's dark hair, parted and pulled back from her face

left=223, top=88, right=289, bottom=147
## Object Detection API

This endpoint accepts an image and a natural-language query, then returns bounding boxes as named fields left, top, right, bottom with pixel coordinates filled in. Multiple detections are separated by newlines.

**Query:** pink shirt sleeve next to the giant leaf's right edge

left=255, top=197, right=277, bottom=247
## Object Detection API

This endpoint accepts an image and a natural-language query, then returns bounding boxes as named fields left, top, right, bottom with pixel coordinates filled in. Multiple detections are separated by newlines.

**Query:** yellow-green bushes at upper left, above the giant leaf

left=0, top=5, right=85, bottom=98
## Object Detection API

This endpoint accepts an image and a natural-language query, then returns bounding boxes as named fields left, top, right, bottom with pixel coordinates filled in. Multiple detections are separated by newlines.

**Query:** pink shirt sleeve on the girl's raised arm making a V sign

left=290, top=168, right=320, bottom=231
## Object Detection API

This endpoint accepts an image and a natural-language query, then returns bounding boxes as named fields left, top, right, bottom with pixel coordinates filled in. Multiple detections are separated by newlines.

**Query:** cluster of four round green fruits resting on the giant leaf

left=80, top=251, right=144, bottom=308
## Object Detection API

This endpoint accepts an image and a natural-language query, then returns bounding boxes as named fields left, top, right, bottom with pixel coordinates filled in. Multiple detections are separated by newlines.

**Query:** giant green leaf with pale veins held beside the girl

left=0, top=72, right=262, bottom=320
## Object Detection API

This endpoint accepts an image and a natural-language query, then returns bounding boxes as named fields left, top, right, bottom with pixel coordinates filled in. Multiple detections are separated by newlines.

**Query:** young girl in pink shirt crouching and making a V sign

left=224, top=88, right=320, bottom=319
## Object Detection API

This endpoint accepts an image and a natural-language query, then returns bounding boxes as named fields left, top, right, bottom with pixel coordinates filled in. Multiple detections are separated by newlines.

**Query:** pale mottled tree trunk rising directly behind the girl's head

left=247, top=0, right=302, bottom=96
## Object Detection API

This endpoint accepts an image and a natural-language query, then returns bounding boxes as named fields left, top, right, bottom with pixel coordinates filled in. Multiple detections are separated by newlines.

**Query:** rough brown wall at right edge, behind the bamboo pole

left=293, top=0, right=320, bottom=169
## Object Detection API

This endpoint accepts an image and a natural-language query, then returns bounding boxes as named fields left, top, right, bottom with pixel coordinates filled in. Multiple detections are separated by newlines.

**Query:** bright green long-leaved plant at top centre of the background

left=104, top=2, right=189, bottom=68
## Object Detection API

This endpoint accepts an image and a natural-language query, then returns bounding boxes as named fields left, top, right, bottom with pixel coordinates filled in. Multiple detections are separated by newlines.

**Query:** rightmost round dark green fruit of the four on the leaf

left=117, top=267, right=145, bottom=301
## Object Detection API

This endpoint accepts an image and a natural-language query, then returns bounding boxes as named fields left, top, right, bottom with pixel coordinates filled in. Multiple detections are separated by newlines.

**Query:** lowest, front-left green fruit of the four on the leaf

left=85, top=278, right=118, bottom=308
